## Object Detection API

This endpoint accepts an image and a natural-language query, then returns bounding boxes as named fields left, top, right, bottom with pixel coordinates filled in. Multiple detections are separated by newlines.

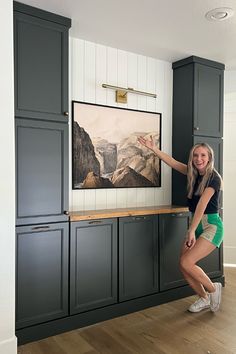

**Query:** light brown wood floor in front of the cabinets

left=18, top=268, right=236, bottom=354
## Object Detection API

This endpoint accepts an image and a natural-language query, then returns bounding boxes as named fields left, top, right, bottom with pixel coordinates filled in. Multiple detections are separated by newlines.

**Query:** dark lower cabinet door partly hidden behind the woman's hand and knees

left=159, top=213, right=190, bottom=291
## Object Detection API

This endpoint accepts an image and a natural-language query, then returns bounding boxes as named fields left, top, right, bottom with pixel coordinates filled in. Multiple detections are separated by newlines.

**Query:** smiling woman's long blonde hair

left=187, top=143, right=222, bottom=198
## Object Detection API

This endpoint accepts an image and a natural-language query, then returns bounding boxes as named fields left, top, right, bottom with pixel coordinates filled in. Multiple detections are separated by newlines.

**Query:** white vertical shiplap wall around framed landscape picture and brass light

left=70, top=38, right=172, bottom=211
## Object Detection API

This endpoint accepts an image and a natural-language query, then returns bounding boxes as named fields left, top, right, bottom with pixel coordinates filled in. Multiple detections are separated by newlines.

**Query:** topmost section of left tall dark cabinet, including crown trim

left=14, top=2, right=70, bottom=121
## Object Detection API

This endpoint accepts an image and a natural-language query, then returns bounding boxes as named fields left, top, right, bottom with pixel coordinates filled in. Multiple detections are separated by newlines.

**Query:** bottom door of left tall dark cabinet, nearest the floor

left=16, top=223, right=69, bottom=329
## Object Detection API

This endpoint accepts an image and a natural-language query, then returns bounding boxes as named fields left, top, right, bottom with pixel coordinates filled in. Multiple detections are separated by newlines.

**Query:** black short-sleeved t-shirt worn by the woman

left=188, top=171, right=221, bottom=214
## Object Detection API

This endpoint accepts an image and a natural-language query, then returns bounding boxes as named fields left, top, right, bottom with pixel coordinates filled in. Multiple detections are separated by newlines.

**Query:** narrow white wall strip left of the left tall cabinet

left=0, top=0, right=17, bottom=354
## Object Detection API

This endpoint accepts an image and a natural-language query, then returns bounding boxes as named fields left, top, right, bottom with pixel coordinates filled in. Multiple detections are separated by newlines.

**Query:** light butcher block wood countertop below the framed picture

left=69, top=205, right=188, bottom=221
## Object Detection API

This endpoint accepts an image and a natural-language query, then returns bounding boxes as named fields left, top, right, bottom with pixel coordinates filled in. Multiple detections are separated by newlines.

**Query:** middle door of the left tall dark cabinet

left=16, top=119, right=68, bottom=225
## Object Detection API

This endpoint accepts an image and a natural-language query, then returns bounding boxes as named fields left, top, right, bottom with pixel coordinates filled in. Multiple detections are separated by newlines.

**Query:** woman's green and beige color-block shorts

left=195, top=213, right=224, bottom=247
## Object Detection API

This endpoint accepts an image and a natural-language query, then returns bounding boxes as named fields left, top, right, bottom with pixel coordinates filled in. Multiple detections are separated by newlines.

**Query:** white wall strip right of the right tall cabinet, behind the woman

left=223, top=71, right=236, bottom=265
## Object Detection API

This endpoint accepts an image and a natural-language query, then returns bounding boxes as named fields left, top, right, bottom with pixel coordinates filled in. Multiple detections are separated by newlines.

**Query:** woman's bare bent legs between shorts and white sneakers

left=180, top=237, right=216, bottom=297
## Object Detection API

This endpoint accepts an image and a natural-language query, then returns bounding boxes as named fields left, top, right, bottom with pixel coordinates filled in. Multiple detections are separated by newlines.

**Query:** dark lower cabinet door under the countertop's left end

left=70, top=219, right=117, bottom=314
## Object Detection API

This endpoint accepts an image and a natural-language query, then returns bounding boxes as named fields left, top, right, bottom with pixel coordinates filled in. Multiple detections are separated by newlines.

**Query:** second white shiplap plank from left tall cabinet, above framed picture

left=84, top=41, right=96, bottom=103
